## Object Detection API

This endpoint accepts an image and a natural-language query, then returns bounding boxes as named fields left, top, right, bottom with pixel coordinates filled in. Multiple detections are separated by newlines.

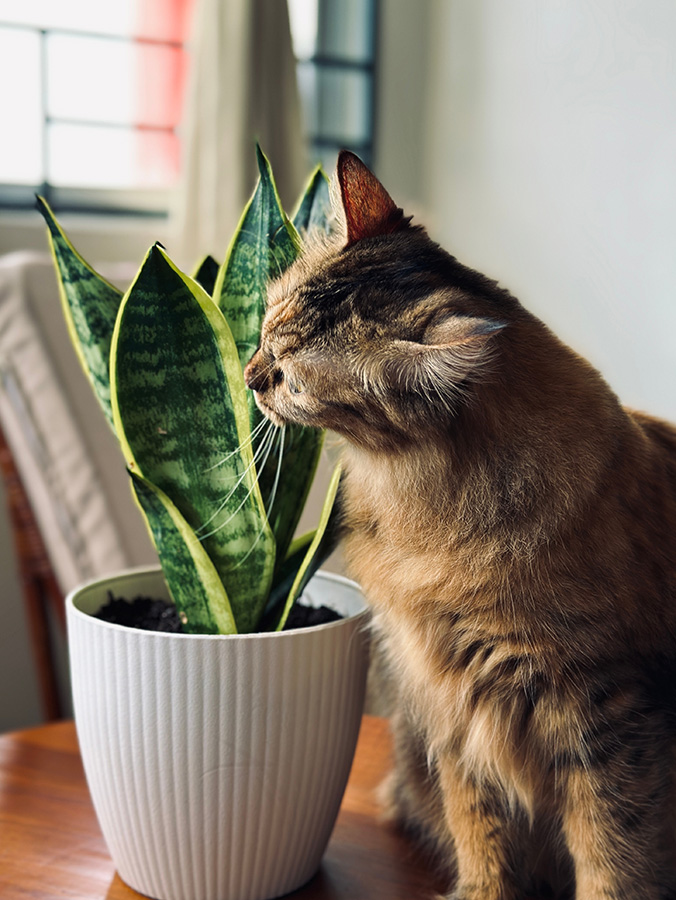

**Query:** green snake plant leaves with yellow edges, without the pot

left=38, top=149, right=340, bottom=634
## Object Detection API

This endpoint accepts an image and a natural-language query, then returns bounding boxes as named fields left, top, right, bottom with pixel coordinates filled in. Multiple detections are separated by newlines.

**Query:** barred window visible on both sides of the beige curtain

left=0, top=0, right=377, bottom=215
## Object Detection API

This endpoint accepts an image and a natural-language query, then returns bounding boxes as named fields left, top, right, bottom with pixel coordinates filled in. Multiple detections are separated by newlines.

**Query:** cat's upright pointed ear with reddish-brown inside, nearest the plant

left=336, top=150, right=411, bottom=247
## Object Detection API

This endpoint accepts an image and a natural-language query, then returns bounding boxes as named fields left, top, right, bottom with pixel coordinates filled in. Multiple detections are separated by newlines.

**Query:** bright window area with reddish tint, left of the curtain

left=0, top=0, right=190, bottom=213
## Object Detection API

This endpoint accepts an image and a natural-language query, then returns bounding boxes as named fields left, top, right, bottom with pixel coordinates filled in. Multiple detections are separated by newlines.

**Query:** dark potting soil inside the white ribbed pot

left=96, top=591, right=342, bottom=633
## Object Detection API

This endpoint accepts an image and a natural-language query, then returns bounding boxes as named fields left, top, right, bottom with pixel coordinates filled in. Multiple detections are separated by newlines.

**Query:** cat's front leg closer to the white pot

left=437, top=756, right=525, bottom=900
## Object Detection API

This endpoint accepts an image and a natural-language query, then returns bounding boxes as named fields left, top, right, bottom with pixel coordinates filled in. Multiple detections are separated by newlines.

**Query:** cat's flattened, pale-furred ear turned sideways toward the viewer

left=388, top=315, right=506, bottom=401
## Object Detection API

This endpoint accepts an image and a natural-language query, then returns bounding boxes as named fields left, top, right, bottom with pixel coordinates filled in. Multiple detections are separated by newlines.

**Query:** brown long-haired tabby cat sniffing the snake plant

left=245, top=151, right=676, bottom=900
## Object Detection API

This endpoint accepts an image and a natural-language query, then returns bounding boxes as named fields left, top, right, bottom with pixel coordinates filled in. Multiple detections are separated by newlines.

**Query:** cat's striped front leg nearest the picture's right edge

left=563, top=744, right=676, bottom=900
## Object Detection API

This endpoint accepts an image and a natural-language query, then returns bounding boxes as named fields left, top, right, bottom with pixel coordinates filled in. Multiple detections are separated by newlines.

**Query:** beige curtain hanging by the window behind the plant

left=172, top=0, right=307, bottom=268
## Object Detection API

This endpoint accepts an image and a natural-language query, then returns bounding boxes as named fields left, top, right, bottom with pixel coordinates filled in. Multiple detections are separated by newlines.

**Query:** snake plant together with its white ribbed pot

left=38, top=150, right=368, bottom=900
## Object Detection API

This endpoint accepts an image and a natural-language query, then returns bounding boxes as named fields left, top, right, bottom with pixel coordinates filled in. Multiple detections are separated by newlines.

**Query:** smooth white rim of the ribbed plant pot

left=65, top=565, right=369, bottom=641
